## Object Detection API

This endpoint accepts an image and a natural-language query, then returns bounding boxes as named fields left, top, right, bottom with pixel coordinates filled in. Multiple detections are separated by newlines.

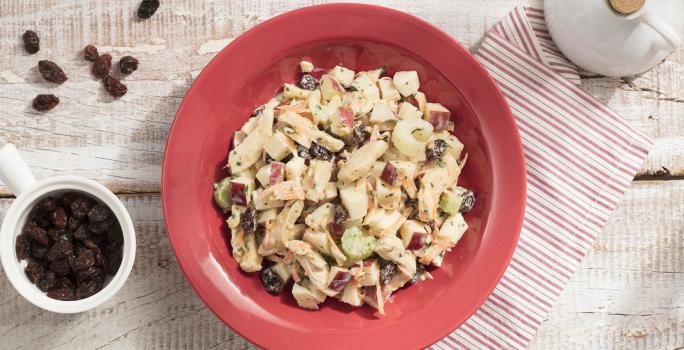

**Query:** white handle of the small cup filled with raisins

left=0, top=143, right=36, bottom=196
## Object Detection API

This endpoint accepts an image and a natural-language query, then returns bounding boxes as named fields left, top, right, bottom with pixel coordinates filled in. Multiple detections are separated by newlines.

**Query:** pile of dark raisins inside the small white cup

left=15, top=192, right=123, bottom=300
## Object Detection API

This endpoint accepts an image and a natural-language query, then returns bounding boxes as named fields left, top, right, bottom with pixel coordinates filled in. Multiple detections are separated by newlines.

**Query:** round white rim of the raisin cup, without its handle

left=0, top=175, right=136, bottom=314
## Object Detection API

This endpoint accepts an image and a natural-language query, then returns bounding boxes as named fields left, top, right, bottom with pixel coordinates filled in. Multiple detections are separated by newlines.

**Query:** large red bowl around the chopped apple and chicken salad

left=162, top=4, right=525, bottom=349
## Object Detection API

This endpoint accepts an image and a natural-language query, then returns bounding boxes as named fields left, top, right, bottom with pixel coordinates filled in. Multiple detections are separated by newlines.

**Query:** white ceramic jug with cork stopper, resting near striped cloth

left=544, top=0, right=684, bottom=77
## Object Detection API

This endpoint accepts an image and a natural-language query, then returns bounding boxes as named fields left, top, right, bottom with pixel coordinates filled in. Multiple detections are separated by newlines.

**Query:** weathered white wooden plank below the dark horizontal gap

left=0, top=181, right=684, bottom=349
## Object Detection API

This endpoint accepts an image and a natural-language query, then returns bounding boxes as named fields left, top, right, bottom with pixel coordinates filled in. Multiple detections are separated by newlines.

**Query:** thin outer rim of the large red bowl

left=161, top=3, right=527, bottom=348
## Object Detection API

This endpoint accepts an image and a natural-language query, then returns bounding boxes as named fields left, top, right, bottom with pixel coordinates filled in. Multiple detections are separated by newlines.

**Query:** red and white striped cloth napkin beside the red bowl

left=433, top=7, right=652, bottom=349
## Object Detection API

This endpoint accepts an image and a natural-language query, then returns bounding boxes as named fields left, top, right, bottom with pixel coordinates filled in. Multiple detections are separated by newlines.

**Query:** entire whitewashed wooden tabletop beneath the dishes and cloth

left=0, top=0, right=684, bottom=349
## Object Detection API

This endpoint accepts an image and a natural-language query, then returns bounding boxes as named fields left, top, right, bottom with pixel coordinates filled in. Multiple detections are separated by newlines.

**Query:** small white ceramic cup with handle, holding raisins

left=0, top=145, right=136, bottom=313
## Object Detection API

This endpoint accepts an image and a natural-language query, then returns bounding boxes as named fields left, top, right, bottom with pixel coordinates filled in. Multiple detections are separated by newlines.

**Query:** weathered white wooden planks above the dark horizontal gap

left=0, top=0, right=684, bottom=195
